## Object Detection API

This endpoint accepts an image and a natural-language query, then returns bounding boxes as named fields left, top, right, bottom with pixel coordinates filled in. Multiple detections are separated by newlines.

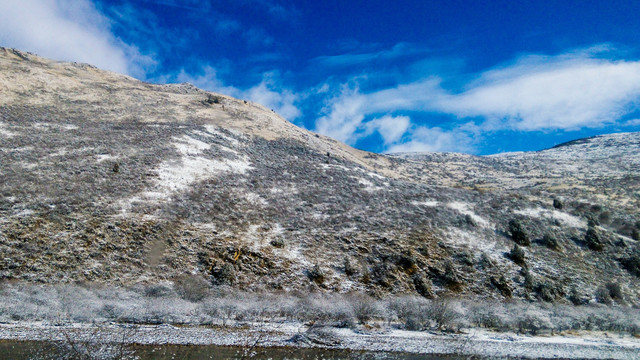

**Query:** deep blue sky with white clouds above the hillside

left=0, top=0, right=640, bottom=154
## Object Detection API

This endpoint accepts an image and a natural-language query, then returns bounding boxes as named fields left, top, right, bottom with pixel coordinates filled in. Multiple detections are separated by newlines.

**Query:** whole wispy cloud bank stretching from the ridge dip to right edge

left=315, top=47, right=640, bottom=151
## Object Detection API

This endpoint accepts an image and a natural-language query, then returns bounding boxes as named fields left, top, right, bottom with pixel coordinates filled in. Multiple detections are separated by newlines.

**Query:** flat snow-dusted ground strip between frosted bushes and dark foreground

left=0, top=322, right=640, bottom=359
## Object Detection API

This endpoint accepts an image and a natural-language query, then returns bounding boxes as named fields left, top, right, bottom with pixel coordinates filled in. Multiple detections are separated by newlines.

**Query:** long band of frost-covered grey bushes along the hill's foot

left=0, top=283, right=640, bottom=334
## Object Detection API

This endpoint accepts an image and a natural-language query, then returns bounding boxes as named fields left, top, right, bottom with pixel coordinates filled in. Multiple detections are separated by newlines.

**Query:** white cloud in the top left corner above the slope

left=0, top=0, right=153, bottom=77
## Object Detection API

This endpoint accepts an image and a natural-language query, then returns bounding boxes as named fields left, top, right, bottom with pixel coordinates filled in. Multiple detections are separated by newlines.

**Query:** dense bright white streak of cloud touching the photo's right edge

left=440, top=57, right=640, bottom=131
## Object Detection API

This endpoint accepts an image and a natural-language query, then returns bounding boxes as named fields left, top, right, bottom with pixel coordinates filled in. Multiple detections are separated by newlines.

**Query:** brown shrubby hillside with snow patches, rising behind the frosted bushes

left=0, top=48, right=640, bottom=303
